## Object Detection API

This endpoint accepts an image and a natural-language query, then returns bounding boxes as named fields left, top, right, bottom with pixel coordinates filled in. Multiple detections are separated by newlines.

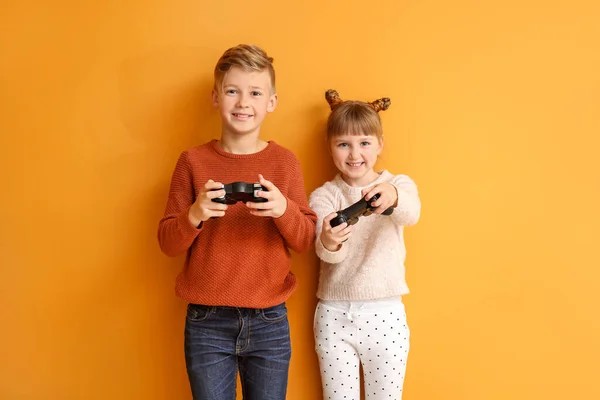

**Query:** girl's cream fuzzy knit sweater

left=309, top=170, right=421, bottom=300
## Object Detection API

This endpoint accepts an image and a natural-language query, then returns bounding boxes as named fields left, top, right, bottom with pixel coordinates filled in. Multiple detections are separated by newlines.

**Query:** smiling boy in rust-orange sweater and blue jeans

left=158, top=45, right=316, bottom=400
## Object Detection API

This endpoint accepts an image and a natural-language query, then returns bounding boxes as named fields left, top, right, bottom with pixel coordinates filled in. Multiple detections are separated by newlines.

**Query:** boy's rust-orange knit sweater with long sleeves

left=158, top=140, right=316, bottom=308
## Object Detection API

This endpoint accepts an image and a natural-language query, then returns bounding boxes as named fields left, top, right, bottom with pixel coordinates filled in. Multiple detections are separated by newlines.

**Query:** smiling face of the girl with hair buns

left=330, top=135, right=383, bottom=187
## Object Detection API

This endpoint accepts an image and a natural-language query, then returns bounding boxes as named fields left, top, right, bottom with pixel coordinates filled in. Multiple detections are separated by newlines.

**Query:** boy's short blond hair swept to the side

left=215, top=44, right=275, bottom=93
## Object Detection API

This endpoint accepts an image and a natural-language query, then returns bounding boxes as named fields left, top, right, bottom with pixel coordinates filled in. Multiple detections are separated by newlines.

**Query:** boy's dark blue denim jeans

left=185, top=303, right=292, bottom=400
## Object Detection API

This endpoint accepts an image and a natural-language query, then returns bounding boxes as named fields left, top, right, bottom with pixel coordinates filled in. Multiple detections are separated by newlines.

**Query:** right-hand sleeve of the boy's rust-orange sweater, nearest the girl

left=274, top=157, right=317, bottom=253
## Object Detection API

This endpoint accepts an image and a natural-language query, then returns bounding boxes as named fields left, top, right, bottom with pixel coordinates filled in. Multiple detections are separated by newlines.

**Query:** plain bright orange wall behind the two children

left=0, top=0, right=600, bottom=400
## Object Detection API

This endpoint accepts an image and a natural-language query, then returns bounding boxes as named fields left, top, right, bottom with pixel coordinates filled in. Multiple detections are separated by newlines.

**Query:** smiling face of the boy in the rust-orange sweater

left=212, top=67, right=277, bottom=135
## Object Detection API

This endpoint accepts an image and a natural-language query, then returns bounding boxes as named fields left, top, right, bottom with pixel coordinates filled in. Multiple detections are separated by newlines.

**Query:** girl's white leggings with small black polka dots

left=314, top=298, right=410, bottom=400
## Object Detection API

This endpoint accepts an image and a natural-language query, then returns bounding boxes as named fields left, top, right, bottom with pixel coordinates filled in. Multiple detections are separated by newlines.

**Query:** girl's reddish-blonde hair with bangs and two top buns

left=325, top=89, right=391, bottom=140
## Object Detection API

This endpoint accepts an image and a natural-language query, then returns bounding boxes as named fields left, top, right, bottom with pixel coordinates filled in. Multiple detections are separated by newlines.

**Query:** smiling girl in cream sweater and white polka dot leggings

left=309, top=90, right=421, bottom=400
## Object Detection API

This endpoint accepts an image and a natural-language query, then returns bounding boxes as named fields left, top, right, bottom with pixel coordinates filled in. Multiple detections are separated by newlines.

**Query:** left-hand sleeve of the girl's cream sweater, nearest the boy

left=309, top=184, right=348, bottom=264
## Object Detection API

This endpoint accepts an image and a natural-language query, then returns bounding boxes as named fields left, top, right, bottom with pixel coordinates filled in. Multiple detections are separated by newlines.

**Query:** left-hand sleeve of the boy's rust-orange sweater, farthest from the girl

left=158, top=151, right=202, bottom=256
